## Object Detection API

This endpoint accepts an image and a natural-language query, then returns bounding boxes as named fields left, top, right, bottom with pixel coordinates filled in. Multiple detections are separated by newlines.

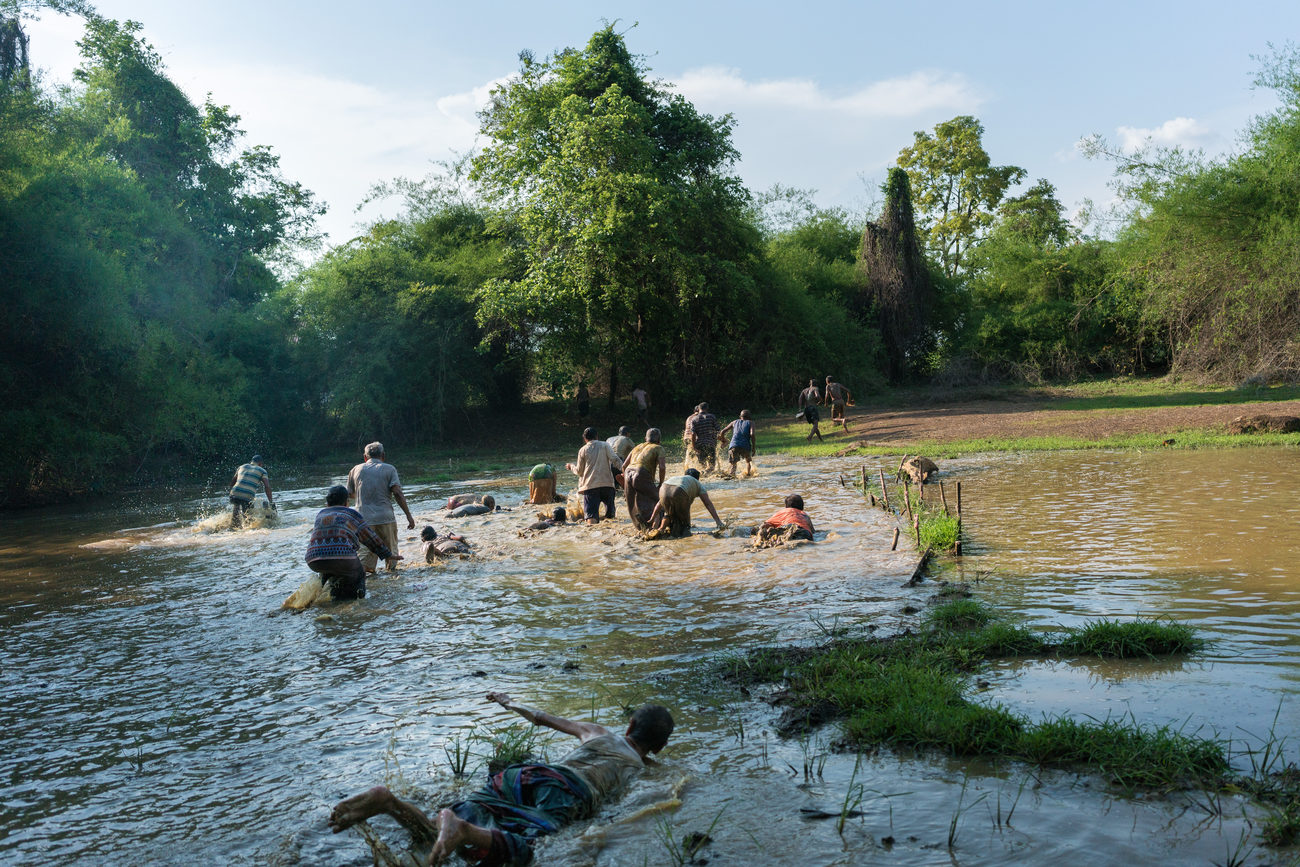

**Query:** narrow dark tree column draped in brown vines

left=858, top=169, right=933, bottom=382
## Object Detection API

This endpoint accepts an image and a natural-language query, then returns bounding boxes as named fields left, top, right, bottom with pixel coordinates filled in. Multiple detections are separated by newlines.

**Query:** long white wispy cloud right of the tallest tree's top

left=677, top=66, right=980, bottom=117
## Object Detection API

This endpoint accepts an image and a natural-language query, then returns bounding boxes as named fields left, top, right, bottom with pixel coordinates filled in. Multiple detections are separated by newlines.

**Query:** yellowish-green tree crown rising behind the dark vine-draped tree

left=898, top=114, right=1024, bottom=277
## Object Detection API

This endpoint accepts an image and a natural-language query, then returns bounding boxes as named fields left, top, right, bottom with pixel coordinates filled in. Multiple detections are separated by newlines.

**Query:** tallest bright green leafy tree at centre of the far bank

left=472, top=27, right=761, bottom=400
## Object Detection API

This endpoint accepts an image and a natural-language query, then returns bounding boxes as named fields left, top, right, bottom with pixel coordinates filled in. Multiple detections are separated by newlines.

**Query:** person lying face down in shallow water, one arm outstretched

left=329, top=693, right=672, bottom=867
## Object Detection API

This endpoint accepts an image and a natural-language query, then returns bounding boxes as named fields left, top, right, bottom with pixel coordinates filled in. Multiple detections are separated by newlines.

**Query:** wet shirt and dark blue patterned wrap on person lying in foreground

left=451, top=733, right=645, bottom=867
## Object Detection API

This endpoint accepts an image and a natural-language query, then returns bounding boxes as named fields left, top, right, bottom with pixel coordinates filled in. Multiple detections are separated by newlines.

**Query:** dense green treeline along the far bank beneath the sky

left=0, top=8, right=1300, bottom=504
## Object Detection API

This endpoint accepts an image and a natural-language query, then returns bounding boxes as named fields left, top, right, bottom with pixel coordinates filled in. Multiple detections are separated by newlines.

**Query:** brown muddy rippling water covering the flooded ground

left=0, top=448, right=1300, bottom=866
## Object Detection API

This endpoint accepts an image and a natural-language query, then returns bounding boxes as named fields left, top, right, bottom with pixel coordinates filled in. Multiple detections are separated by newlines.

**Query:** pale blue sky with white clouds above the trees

left=26, top=0, right=1300, bottom=243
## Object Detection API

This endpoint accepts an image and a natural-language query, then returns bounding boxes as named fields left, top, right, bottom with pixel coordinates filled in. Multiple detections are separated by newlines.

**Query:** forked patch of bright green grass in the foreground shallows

left=724, top=599, right=1229, bottom=789
